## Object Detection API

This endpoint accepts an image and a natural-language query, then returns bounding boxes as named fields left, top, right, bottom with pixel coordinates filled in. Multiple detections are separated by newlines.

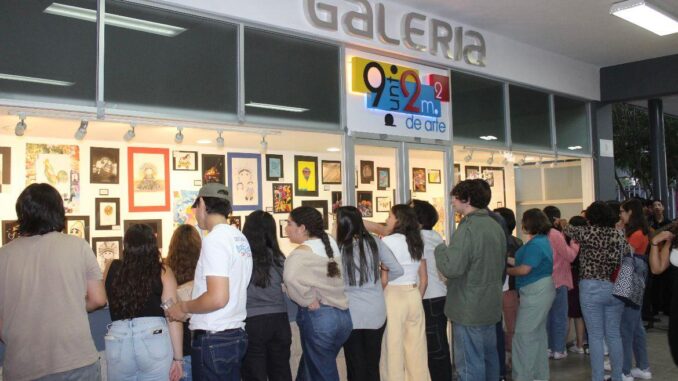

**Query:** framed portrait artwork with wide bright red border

left=127, top=147, right=170, bottom=212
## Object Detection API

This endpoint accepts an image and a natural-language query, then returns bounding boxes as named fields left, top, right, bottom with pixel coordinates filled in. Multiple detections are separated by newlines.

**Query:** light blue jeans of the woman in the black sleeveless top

left=104, top=317, right=172, bottom=381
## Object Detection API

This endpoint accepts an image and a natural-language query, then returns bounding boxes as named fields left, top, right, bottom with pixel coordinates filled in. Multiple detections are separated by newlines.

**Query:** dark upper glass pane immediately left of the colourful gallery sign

left=245, top=28, right=339, bottom=129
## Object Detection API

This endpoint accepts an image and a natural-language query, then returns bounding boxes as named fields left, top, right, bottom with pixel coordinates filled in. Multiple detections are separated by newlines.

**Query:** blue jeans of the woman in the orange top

left=621, top=306, right=650, bottom=375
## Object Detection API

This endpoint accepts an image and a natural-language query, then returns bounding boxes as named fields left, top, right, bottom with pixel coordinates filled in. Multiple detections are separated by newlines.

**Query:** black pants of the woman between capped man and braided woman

left=241, top=312, right=292, bottom=381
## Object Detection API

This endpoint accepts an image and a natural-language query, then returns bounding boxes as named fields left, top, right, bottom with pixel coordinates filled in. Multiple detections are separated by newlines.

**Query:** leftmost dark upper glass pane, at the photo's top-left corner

left=0, top=0, right=97, bottom=106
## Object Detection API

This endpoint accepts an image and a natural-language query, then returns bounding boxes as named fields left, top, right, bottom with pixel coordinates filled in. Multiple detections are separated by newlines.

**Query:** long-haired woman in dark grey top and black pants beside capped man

left=242, top=210, right=292, bottom=381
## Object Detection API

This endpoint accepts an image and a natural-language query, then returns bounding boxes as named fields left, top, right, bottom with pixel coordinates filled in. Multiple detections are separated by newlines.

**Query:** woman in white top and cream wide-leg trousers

left=379, top=204, right=431, bottom=381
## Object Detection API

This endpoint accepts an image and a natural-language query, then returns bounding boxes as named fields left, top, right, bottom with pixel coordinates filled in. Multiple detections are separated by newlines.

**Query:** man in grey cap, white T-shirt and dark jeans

left=166, top=183, right=252, bottom=381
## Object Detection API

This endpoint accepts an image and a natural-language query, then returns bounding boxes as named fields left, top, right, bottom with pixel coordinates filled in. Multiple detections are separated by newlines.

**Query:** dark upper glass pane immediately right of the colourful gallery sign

left=451, top=71, right=506, bottom=146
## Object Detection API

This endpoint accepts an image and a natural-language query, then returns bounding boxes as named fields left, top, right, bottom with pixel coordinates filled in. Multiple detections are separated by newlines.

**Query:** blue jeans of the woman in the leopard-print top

left=579, top=279, right=624, bottom=381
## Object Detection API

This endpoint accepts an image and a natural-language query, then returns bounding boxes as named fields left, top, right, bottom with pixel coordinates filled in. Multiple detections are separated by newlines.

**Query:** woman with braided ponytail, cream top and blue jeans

left=283, top=206, right=353, bottom=381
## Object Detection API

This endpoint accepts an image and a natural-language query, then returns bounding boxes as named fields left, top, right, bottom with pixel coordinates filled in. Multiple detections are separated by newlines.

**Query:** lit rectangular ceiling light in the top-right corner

left=610, top=0, right=678, bottom=36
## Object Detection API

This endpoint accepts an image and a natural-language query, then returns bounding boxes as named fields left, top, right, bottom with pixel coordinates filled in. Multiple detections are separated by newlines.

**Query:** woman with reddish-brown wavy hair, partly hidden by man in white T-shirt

left=166, top=224, right=202, bottom=381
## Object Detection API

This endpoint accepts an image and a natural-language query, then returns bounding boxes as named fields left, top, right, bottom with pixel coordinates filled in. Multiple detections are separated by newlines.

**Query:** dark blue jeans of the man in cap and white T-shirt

left=191, top=328, right=247, bottom=381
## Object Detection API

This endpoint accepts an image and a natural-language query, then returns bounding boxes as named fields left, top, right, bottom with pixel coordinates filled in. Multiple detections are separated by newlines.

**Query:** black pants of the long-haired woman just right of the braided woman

left=344, top=324, right=386, bottom=381
